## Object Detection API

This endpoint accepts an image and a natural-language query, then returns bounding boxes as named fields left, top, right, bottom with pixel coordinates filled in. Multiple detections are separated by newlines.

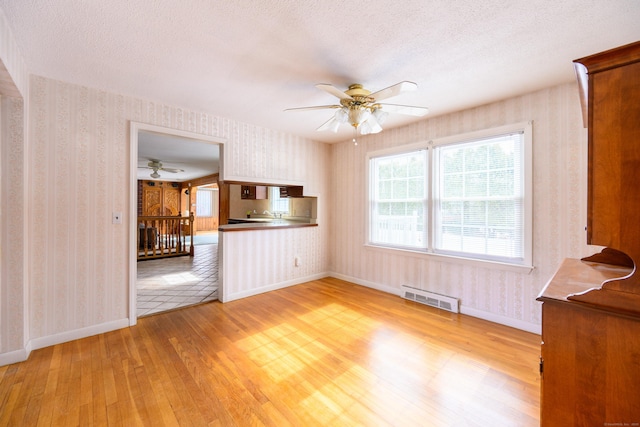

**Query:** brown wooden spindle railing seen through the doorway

left=136, top=214, right=193, bottom=260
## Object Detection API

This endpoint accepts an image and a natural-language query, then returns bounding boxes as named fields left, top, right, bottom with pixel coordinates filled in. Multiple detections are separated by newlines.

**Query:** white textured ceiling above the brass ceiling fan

left=0, top=0, right=640, bottom=142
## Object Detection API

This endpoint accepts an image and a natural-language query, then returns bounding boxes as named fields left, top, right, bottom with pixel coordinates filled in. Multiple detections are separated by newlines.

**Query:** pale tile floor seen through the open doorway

left=137, top=244, right=218, bottom=317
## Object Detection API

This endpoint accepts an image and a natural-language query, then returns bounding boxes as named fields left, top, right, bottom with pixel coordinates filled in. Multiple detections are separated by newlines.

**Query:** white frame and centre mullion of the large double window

left=365, top=121, right=533, bottom=272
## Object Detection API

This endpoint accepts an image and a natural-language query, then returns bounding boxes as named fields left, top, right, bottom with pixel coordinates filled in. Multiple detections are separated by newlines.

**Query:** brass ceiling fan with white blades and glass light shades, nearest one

left=285, top=81, right=429, bottom=135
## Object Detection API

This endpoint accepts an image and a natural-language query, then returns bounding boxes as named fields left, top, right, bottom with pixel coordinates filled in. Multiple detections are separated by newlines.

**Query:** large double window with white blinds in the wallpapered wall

left=369, top=123, right=532, bottom=265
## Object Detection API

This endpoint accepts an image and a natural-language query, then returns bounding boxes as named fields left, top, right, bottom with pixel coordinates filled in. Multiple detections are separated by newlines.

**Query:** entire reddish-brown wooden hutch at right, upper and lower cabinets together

left=538, top=42, right=640, bottom=426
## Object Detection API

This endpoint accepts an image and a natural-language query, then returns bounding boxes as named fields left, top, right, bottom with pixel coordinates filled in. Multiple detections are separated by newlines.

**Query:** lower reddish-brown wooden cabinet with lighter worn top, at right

left=538, top=259, right=640, bottom=427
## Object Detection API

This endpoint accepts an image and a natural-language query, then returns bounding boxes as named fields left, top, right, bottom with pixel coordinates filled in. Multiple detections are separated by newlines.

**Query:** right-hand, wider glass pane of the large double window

left=434, top=133, right=524, bottom=259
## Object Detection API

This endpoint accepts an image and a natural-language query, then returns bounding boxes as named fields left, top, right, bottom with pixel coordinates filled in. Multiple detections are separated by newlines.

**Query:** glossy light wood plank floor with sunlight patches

left=0, top=279, right=540, bottom=427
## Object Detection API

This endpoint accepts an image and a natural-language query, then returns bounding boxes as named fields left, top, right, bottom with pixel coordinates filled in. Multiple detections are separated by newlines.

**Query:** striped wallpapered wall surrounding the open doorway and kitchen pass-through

left=28, top=76, right=330, bottom=339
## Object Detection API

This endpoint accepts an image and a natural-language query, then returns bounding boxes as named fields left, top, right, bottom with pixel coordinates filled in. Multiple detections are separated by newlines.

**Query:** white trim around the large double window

left=364, top=121, right=534, bottom=273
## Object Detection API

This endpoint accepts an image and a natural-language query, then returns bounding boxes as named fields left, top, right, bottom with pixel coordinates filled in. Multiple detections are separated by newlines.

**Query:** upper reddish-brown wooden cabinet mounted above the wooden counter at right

left=576, top=43, right=640, bottom=264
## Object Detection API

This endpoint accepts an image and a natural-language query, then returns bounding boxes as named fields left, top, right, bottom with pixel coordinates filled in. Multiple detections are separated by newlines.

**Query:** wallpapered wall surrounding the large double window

left=331, top=84, right=600, bottom=331
